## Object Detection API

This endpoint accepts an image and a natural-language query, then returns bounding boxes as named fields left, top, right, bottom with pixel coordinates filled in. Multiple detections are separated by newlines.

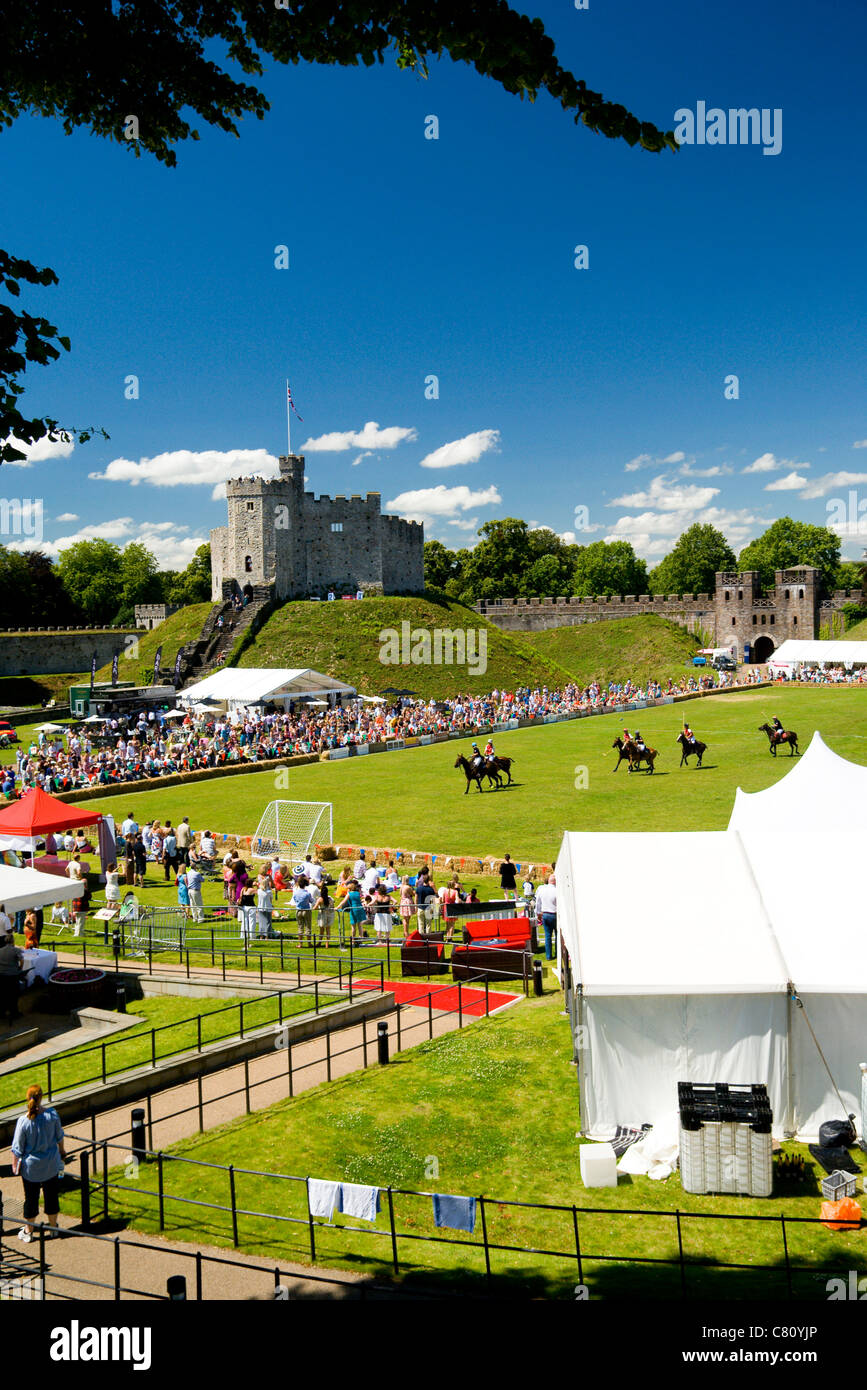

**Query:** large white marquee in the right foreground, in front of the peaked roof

left=557, top=739, right=867, bottom=1138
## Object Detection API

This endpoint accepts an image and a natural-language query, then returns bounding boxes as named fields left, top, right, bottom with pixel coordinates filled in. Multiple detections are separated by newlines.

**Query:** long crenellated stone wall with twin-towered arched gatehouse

left=475, top=566, right=863, bottom=662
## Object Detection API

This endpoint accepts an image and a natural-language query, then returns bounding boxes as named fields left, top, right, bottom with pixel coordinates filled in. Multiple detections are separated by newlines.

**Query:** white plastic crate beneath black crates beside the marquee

left=681, top=1120, right=774, bottom=1197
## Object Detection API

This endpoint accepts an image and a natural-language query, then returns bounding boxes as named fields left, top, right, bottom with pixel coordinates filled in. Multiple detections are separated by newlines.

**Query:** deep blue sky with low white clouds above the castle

left=0, top=0, right=867, bottom=567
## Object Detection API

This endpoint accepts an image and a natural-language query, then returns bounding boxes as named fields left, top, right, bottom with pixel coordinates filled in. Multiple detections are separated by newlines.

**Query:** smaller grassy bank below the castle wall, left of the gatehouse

left=521, top=613, right=699, bottom=685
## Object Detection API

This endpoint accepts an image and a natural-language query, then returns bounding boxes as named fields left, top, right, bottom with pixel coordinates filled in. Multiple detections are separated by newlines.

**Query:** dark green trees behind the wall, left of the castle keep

left=0, top=539, right=211, bottom=627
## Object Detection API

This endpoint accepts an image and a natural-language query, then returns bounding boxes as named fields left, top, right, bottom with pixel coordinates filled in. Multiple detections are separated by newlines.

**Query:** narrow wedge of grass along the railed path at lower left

left=0, top=994, right=323, bottom=1111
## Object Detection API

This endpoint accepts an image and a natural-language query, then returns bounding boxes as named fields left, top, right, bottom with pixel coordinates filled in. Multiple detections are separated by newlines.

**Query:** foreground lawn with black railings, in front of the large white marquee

left=83, top=992, right=864, bottom=1298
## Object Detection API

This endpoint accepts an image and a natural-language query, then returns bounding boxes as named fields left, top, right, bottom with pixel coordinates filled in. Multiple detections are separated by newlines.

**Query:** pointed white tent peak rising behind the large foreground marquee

left=728, top=728, right=867, bottom=834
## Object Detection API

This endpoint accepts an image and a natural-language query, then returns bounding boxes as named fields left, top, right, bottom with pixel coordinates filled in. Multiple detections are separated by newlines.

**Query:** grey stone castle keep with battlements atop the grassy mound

left=211, top=455, right=424, bottom=602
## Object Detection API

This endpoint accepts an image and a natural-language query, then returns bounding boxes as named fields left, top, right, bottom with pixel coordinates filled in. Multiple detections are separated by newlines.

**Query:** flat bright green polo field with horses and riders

left=81, top=687, right=867, bottom=862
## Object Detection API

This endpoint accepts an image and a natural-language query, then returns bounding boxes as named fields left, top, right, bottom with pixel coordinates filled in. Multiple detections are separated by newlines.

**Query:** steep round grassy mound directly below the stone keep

left=238, top=598, right=568, bottom=696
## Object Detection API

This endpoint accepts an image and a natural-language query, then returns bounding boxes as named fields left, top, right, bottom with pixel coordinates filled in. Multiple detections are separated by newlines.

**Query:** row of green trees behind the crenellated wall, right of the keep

left=425, top=517, right=864, bottom=603
